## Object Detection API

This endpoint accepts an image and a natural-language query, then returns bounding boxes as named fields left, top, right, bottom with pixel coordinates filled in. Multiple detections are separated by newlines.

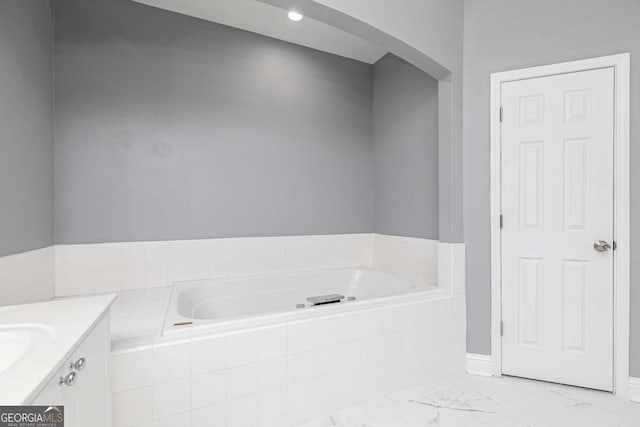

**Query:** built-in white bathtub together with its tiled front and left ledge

left=111, top=267, right=466, bottom=427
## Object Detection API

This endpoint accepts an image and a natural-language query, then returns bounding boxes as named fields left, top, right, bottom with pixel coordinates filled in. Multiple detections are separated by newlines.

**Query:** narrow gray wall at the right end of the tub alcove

left=373, top=54, right=438, bottom=239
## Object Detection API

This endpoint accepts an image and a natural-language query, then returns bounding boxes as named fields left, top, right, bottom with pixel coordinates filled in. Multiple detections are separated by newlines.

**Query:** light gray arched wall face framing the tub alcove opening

left=284, top=0, right=464, bottom=243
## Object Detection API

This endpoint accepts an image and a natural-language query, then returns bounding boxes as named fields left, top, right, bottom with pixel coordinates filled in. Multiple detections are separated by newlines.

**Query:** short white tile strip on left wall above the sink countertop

left=0, top=246, right=54, bottom=306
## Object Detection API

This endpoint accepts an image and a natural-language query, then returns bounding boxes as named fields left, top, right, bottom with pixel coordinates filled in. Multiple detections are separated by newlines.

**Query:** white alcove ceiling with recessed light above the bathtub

left=134, top=0, right=387, bottom=64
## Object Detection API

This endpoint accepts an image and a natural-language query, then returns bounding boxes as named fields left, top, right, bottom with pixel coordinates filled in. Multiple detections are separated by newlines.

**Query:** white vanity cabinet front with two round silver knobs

left=32, top=313, right=111, bottom=427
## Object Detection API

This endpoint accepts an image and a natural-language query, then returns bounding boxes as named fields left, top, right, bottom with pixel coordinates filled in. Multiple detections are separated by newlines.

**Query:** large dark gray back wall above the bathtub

left=55, top=0, right=373, bottom=243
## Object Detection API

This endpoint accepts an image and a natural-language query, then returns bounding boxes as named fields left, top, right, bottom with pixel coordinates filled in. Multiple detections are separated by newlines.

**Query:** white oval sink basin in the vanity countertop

left=0, top=324, right=55, bottom=375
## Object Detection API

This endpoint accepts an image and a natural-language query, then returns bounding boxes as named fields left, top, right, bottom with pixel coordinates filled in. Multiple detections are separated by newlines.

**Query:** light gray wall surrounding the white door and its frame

left=464, top=0, right=640, bottom=376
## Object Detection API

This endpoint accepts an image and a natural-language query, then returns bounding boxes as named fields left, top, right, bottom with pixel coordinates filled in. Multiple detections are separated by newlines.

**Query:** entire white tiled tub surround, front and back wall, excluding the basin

left=50, top=234, right=465, bottom=427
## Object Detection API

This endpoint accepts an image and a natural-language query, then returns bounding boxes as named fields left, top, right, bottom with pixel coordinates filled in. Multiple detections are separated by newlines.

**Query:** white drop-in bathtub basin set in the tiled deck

left=162, top=268, right=437, bottom=335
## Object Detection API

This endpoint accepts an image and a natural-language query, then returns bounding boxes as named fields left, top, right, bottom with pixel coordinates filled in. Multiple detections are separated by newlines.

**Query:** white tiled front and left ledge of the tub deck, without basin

left=112, top=288, right=465, bottom=427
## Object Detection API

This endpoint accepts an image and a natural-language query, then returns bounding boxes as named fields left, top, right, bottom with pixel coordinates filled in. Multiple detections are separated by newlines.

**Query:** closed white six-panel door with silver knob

left=501, top=68, right=614, bottom=390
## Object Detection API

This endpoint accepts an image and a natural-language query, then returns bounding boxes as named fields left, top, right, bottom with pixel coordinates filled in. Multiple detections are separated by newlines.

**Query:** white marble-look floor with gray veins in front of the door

left=301, top=374, right=640, bottom=427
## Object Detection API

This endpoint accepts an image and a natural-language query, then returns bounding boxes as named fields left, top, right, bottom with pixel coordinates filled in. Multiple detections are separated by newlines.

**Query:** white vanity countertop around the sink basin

left=0, top=294, right=115, bottom=405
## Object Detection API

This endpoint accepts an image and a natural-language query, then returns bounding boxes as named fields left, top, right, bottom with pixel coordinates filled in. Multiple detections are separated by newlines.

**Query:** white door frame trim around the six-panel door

left=490, top=53, right=631, bottom=397
